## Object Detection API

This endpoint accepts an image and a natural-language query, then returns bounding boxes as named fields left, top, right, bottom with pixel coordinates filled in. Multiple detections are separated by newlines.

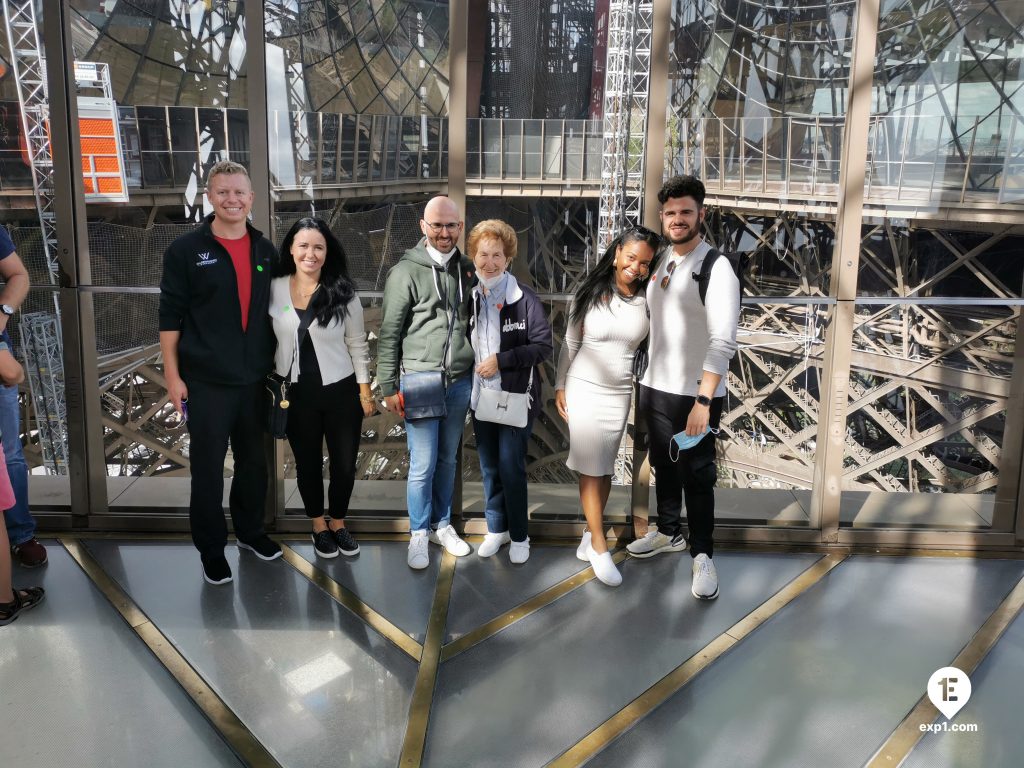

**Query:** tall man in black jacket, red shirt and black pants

left=160, top=161, right=281, bottom=584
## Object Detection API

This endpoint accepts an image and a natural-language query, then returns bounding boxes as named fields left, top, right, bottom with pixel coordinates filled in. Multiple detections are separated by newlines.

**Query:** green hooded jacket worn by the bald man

left=377, top=239, right=474, bottom=397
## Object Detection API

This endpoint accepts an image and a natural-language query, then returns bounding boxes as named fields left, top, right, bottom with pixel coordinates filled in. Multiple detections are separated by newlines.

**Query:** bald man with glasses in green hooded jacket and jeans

left=377, top=197, right=473, bottom=569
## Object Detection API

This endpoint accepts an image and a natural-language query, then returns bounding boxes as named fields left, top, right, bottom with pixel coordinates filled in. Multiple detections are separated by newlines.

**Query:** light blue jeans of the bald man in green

left=406, top=375, right=473, bottom=530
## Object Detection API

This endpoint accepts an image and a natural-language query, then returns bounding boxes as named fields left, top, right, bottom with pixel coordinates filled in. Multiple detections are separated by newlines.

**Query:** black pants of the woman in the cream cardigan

left=287, top=374, right=362, bottom=520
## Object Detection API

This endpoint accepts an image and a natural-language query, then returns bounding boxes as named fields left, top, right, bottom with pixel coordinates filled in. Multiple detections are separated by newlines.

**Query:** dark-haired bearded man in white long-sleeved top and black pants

left=627, top=176, right=739, bottom=600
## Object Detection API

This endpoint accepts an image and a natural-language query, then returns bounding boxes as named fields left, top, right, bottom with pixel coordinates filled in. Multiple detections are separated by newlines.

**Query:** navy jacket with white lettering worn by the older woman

left=469, top=274, right=553, bottom=413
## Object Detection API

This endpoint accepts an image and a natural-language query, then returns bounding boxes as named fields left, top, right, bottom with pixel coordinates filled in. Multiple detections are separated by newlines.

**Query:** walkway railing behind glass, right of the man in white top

left=667, top=115, right=1024, bottom=205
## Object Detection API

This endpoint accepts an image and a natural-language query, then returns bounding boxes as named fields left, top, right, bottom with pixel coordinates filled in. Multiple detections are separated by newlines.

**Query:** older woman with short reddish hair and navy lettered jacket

left=466, top=219, right=551, bottom=563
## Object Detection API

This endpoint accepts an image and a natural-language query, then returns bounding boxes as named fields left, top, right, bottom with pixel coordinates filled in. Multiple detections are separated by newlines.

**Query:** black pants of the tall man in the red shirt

left=185, top=381, right=267, bottom=554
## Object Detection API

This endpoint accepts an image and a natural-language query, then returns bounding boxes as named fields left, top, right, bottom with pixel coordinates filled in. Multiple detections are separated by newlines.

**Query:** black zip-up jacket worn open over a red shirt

left=160, top=214, right=278, bottom=385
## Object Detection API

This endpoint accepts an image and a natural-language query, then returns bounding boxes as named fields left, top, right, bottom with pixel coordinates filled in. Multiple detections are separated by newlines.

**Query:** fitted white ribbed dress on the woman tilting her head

left=555, top=293, right=650, bottom=477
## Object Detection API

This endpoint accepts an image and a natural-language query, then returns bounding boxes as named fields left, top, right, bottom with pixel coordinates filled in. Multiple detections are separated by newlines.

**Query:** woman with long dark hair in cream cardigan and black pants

left=270, top=218, right=375, bottom=557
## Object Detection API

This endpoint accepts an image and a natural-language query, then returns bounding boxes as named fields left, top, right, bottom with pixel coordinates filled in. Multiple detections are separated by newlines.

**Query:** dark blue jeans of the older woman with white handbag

left=473, top=414, right=534, bottom=542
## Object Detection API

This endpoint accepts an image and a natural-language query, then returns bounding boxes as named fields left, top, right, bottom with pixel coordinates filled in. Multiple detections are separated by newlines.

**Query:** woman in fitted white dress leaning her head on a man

left=555, top=226, right=662, bottom=587
